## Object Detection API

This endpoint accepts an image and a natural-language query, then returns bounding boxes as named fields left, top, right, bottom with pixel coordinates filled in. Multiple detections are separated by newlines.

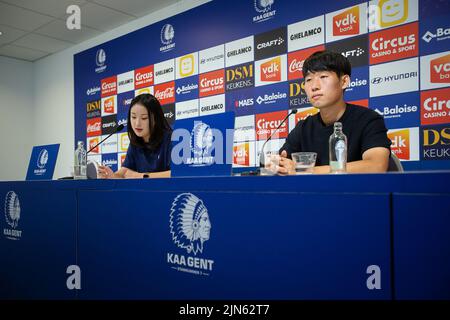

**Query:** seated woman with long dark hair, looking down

left=98, top=94, right=172, bottom=179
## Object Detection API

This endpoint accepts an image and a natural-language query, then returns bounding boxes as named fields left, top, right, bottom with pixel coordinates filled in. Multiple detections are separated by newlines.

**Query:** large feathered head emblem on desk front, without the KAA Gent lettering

left=170, top=193, right=211, bottom=255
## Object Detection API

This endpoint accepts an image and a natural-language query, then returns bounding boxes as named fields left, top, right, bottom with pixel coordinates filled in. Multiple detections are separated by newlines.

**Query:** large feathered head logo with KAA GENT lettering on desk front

left=167, top=193, right=214, bottom=275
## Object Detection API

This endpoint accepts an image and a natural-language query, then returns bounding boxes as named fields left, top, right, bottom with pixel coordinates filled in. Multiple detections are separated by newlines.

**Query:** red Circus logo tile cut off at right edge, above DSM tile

left=420, top=88, right=450, bottom=125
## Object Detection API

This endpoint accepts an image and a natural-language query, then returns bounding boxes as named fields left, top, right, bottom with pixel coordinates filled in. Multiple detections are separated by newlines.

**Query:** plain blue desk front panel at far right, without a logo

left=393, top=194, right=450, bottom=300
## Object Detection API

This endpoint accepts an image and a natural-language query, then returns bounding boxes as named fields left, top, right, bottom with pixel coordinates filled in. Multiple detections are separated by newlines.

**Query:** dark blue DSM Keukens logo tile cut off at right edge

left=422, top=123, right=450, bottom=160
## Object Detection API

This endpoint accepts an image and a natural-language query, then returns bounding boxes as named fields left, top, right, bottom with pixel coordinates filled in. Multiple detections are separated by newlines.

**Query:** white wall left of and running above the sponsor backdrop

left=0, top=0, right=211, bottom=180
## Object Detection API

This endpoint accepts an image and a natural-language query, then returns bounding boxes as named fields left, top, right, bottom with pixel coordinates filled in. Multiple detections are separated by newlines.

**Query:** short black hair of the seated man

left=303, top=50, right=352, bottom=77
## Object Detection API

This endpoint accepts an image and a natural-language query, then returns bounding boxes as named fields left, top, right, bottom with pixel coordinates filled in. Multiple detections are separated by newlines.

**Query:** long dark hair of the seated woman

left=127, top=93, right=172, bottom=150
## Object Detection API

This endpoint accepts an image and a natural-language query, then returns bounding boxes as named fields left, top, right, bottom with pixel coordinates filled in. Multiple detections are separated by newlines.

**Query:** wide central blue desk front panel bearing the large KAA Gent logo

left=78, top=189, right=391, bottom=299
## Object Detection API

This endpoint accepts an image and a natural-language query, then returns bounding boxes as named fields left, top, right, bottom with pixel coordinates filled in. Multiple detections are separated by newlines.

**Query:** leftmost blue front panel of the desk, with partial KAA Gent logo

left=0, top=182, right=76, bottom=299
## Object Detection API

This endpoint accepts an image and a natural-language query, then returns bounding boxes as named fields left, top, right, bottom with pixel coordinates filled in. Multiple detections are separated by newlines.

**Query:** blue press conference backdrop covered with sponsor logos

left=74, top=0, right=450, bottom=170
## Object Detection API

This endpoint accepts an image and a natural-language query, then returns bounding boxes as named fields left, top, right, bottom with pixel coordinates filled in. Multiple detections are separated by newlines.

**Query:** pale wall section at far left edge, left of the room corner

left=0, top=57, right=34, bottom=181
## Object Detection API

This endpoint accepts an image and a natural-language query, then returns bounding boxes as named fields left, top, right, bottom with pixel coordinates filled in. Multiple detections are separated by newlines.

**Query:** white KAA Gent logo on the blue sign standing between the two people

left=186, top=121, right=214, bottom=167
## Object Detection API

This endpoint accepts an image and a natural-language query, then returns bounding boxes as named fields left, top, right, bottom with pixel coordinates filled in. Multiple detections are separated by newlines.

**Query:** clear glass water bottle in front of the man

left=329, top=122, right=347, bottom=173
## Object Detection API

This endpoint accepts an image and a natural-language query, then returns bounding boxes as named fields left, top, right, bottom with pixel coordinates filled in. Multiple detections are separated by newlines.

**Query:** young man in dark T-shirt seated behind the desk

left=277, top=51, right=391, bottom=174
